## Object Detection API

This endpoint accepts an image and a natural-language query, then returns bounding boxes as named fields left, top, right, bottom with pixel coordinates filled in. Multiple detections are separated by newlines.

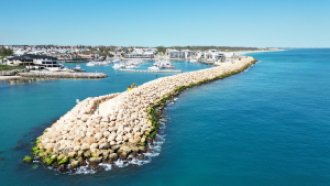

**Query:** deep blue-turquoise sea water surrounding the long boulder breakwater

left=0, top=49, right=330, bottom=186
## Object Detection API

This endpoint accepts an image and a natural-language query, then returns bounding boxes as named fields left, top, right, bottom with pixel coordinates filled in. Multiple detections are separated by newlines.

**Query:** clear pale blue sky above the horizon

left=0, top=0, right=330, bottom=47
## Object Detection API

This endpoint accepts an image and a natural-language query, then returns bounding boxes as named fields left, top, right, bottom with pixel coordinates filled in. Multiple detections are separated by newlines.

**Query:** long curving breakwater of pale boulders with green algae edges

left=23, top=57, right=256, bottom=171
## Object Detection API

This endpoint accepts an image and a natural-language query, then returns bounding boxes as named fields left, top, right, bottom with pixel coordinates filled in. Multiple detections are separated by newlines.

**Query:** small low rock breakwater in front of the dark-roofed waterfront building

left=19, top=72, right=108, bottom=78
